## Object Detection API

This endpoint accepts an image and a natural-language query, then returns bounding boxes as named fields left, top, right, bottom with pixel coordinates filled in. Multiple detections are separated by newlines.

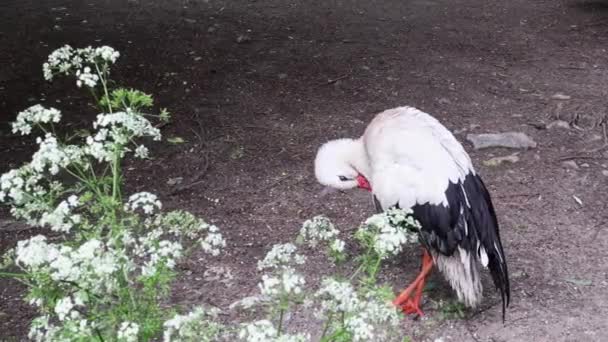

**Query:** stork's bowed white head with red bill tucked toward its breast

left=315, top=139, right=371, bottom=191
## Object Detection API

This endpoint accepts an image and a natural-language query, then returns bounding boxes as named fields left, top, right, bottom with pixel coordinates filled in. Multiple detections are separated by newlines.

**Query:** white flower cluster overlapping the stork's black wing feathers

left=358, top=209, right=419, bottom=259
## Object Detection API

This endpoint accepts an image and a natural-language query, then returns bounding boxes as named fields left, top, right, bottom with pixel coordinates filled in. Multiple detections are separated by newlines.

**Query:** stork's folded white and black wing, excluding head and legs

left=363, top=107, right=510, bottom=314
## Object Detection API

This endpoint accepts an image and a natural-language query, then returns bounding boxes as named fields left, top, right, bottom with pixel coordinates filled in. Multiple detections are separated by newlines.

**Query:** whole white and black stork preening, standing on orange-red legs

left=314, top=106, right=511, bottom=322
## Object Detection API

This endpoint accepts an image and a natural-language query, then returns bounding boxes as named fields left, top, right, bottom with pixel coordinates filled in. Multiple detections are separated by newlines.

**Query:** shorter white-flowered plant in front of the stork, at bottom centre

left=239, top=209, right=420, bottom=342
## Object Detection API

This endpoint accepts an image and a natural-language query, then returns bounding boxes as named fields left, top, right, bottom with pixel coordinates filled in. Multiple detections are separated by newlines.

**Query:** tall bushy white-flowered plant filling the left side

left=0, top=46, right=225, bottom=341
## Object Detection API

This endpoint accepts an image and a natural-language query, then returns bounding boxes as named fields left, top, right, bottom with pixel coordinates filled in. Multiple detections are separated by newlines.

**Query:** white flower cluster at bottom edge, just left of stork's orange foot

left=316, top=278, right=400, bottom=341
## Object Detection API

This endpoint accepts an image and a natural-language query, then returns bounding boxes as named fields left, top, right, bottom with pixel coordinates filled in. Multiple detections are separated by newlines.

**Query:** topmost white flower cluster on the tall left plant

left=42, top=45, right=120, bottom=88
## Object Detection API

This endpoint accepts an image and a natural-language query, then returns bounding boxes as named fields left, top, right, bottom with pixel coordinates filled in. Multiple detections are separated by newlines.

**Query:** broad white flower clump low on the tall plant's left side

left=15, top=235, right=122, bottom=293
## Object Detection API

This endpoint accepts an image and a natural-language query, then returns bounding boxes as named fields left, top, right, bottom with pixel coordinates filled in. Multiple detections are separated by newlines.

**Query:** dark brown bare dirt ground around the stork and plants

left=0, top=0, right=608, bottom=341
